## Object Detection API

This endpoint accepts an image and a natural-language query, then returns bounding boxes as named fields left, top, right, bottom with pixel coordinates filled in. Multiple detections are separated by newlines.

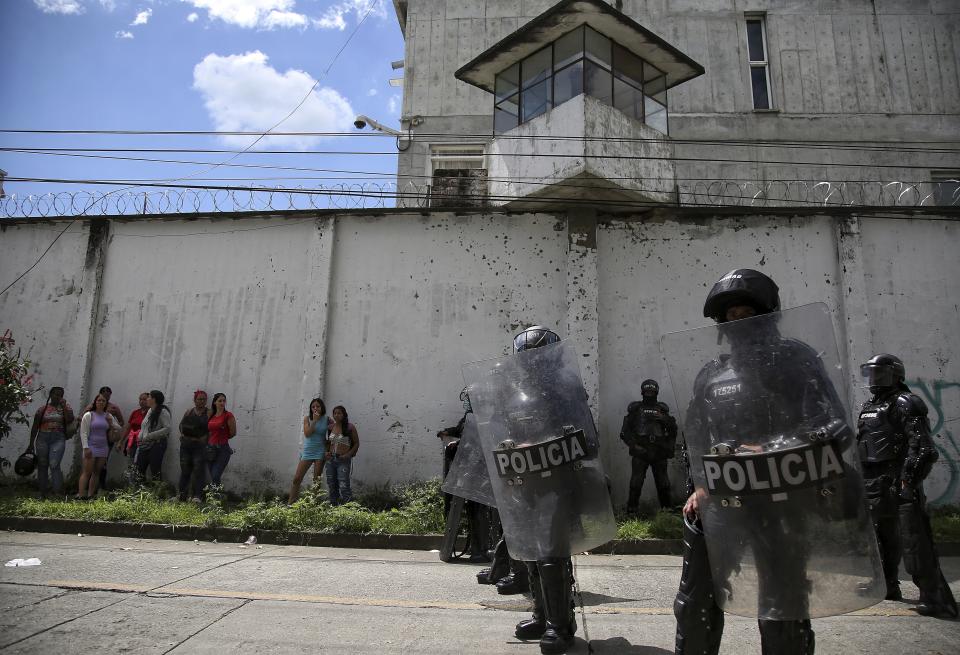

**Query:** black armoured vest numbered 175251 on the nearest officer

left=702, top=357, right=805, bottom=448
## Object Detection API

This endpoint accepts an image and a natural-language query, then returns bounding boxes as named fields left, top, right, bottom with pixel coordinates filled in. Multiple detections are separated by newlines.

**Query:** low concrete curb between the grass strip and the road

left=0, top=516, right=683, bottom=555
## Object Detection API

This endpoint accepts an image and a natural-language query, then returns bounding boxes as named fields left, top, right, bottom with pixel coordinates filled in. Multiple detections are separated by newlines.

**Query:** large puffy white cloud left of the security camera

left=193, top=50, right=354, bottom=150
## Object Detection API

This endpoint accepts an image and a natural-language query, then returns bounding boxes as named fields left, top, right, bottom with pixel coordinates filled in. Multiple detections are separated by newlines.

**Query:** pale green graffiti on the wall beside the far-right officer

left=907, top=378, right=960, bottom=505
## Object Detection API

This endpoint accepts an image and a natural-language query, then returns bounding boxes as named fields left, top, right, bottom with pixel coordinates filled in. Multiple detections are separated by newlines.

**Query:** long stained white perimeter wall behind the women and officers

left=0, top=209, right=960, bottom=504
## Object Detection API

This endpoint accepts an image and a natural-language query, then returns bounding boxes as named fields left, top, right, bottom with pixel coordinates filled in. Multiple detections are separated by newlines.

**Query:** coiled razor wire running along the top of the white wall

left=0, top=178, right=960, bottom=220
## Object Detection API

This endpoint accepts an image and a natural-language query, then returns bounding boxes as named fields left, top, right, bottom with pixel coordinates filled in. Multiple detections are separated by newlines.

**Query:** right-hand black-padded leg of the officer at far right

left=900, top=488, right=957, bottom=618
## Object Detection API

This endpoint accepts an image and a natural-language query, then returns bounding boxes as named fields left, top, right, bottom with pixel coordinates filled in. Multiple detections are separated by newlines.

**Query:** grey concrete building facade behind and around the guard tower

left=394, top=0, right=960, bottom=206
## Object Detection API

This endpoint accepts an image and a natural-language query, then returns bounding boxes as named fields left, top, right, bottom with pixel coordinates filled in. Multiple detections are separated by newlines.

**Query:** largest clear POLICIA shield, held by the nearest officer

left=661, top=303, right=885, bottom=620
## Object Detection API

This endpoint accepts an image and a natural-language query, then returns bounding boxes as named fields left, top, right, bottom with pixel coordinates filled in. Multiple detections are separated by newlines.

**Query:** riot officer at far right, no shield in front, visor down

left=857, top=354, right=957, bottom=618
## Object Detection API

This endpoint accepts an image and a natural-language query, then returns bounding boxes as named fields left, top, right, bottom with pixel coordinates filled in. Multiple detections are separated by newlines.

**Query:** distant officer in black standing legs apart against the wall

left=620, top=380, right=677, bottom=513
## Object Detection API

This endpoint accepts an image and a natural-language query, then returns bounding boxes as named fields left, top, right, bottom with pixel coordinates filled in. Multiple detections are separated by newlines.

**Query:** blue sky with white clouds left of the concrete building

left=0, top=0, right=403, bottom=210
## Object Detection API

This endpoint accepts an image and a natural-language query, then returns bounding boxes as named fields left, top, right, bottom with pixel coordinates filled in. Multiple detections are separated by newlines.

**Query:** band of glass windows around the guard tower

left=493, top=25, right=668, bottom=134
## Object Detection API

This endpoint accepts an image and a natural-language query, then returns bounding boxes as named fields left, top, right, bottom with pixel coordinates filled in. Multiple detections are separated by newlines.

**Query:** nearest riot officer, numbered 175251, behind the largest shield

left=674, top=269, right=859, bottom=655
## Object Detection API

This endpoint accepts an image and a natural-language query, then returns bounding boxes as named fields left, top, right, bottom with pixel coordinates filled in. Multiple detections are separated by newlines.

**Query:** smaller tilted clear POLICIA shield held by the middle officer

left=463, top=342, right=616, bottom=561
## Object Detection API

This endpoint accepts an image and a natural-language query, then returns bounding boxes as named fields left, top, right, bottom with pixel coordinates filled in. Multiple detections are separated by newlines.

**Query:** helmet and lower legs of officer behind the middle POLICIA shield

left=513, top=325, right=577, bottom=653
